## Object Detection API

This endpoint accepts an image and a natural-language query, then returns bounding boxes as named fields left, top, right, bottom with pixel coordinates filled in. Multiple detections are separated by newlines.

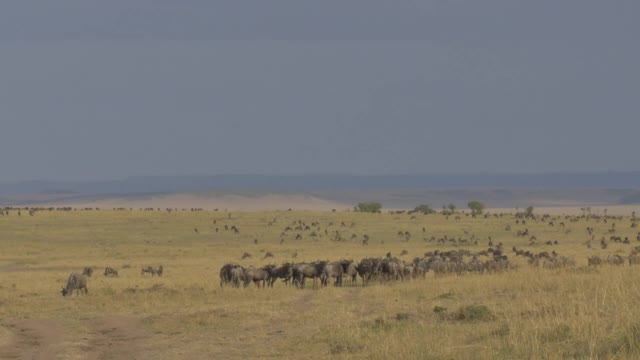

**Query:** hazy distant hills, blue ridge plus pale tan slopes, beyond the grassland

left=0, top=172, right=640, bottom=209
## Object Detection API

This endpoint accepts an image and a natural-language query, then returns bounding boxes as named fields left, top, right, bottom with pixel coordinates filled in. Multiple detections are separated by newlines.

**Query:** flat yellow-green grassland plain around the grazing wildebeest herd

left=0, top=210, right=640, bottom=359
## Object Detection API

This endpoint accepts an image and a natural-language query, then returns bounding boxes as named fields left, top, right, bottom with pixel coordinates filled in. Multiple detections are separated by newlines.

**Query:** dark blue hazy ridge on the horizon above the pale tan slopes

left=0, top=171, right=640, bottom=196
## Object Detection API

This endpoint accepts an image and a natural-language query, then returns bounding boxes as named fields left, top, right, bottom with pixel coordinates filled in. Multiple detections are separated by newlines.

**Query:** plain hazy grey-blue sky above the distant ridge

left=0, top=0, right=640, bottom=182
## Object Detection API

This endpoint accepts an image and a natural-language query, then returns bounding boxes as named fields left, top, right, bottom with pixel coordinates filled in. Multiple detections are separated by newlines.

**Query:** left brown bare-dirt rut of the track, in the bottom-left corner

left=0, top=319, right=64, bottom=360
